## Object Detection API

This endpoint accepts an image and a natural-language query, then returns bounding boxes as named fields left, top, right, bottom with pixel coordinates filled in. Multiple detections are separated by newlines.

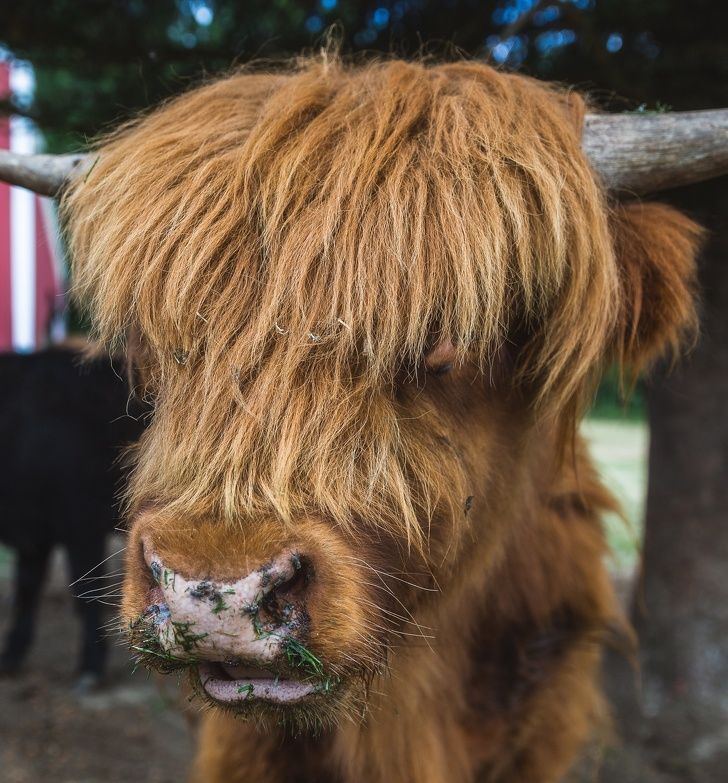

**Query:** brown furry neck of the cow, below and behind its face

left=327, top=428, right=620, bottom=783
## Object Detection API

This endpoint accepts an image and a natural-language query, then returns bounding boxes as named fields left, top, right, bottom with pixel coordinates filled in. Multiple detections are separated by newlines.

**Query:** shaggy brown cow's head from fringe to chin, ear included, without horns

left=2, top=61, right=698, bottom=726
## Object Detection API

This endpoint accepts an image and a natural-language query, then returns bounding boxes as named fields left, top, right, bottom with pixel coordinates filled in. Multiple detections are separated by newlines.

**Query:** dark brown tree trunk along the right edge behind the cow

left=604, top=179, right=728, bottom=783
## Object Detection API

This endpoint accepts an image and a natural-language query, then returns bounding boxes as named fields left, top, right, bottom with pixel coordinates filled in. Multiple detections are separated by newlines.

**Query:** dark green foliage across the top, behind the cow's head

left=0, top=0, right=728, bottom=146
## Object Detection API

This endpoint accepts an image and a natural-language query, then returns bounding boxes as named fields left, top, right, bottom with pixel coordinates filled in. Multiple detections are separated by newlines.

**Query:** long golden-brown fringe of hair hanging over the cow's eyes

left=63, top=56, right=618, bottom=540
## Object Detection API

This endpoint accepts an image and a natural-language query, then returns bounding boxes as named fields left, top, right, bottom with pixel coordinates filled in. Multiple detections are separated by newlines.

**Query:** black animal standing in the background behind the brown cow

left=0, top=346, right=142, bottom=683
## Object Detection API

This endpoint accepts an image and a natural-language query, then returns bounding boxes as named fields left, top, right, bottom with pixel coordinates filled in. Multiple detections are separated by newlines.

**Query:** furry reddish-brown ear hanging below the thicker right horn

left=611, top=203, right=704, bottom=377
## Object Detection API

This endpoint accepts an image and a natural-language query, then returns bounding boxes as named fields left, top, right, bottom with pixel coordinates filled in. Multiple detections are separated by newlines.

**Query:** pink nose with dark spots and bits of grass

left=144, top=545, right=312, bottom=663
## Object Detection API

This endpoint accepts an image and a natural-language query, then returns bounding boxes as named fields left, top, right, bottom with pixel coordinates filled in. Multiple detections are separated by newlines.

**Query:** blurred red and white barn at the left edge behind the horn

left=0, top=61, right=64, bottom=351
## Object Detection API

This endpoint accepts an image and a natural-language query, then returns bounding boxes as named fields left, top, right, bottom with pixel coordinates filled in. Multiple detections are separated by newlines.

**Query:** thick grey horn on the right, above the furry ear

left=582, top=109, right=728, bottom=195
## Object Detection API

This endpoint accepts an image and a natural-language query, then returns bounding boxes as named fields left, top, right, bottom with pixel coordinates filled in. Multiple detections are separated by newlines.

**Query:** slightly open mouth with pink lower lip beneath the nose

left=198, top=661, right=328, bottom=706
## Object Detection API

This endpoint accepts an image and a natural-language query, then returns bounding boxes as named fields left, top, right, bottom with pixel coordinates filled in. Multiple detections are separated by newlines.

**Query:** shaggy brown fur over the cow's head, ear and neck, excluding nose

left=64, top=57, right=698, bottom=783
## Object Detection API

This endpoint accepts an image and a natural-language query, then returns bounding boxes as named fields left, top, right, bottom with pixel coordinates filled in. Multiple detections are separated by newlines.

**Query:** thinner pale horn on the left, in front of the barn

left=0, top=150, right=90, bottom=196
